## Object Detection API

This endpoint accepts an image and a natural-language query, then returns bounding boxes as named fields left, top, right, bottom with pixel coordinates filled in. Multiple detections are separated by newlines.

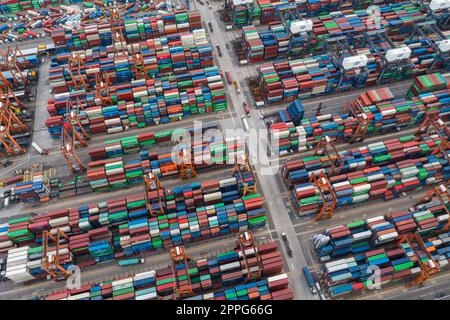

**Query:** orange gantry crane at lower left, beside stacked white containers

left=42, top=227, right=71, bottom=280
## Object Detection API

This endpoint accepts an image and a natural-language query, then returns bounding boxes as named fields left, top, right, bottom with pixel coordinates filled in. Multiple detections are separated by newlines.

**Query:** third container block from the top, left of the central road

left=46, top=67, right=227, bottom=138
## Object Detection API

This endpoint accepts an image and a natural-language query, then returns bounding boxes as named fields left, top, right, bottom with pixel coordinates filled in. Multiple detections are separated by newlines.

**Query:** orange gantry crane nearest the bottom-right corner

left=395, top=233, right=440, bottom=287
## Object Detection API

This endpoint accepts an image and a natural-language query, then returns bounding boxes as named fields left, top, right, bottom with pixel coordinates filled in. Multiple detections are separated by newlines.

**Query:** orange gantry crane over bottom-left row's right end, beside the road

left=237, top=231, right=262, bottom=281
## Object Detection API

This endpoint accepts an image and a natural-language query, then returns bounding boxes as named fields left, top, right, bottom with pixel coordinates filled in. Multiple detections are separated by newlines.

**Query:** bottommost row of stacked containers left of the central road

left=41, top=243, right=292, bottom=300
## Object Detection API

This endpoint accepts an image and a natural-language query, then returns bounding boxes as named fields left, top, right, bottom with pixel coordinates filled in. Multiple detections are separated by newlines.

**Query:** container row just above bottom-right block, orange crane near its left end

left=292, top=155, right=450, bottom=215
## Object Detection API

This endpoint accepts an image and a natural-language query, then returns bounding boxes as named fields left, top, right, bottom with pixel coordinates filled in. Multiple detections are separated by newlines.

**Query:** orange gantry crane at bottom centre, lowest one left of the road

left=170, top=246, right=194, bottom=300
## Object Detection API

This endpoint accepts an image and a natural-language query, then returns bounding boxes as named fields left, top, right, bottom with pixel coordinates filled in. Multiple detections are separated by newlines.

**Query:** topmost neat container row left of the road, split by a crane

left=51, top=11, right=202, bottom=51
